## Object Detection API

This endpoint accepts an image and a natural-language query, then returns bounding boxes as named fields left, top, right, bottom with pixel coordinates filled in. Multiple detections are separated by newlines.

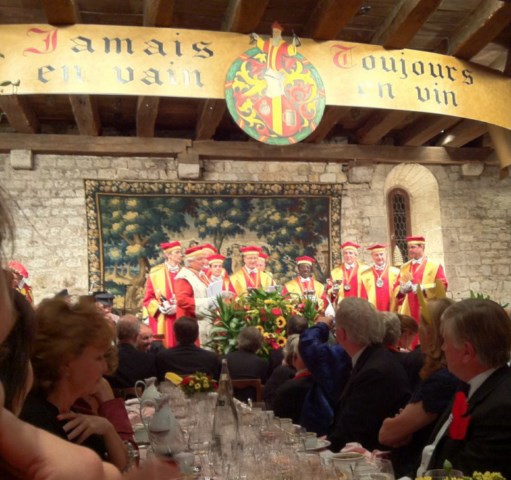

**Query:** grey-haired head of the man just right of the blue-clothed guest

left=335, top=297, right=384, bottom=346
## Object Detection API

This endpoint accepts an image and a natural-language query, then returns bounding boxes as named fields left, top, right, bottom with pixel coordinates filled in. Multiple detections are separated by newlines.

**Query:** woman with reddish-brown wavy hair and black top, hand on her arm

left=20, top=298, right=128, bottom=469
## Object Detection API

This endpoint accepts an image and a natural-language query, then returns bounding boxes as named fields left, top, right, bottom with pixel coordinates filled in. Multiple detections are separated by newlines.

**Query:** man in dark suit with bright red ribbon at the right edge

left=419, top=299, right=511, bottom=478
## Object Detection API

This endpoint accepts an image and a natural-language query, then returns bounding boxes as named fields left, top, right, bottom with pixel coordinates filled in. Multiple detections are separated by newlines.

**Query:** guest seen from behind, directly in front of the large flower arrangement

left=225, top=327, right=268, bottom=402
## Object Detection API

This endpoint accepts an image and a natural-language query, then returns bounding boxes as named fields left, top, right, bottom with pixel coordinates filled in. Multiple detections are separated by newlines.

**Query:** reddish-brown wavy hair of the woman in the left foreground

left=32, top=298, right=114, bottom=392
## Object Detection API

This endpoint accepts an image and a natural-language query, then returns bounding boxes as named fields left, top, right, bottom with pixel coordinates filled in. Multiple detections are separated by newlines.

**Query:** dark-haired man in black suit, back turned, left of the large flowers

left=156, top=317, right=220, bottom=380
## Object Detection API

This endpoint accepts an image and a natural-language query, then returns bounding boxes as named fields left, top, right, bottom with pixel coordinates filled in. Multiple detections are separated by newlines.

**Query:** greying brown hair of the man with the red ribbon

left=441, top=298, right=511, bottom=368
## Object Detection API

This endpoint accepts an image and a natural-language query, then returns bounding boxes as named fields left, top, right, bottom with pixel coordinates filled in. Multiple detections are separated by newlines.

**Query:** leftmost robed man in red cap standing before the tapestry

left=143, top=241, right=183, bottom=348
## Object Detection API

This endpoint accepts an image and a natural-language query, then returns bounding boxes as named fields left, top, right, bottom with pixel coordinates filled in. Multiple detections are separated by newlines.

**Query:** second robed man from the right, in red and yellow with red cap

left=360, top=244, right=399, bottom=312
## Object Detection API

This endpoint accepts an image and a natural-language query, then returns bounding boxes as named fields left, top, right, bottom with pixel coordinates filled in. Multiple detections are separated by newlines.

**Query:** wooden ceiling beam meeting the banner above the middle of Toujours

left=371, top=0, right=442, bottom=48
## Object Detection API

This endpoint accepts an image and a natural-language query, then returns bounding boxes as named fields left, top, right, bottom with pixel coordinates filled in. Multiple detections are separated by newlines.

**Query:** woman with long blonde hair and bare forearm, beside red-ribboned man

left=379, top=298, right=460, bottom=475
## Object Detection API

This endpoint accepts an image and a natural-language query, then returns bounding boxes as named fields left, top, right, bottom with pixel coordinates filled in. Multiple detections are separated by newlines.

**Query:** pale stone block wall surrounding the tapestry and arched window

left=0, top=154, right=511, bottom=301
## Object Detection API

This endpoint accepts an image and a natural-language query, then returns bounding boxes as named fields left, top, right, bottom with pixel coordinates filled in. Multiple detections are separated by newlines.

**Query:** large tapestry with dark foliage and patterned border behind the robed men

left=85, top=180, right=342, bottom=313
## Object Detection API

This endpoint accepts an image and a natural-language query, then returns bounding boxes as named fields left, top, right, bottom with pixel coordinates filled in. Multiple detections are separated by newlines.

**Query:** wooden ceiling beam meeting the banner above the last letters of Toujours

left=445, top=0, right=511, bottom=60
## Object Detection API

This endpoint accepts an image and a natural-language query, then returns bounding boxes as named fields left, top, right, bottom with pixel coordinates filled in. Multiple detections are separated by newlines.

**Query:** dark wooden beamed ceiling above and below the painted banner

left=0, top=0, right=511, bottom=164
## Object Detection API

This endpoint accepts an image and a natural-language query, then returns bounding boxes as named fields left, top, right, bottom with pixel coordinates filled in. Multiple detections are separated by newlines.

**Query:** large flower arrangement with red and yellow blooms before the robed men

left=208, top=289, right=316, bottom=357
